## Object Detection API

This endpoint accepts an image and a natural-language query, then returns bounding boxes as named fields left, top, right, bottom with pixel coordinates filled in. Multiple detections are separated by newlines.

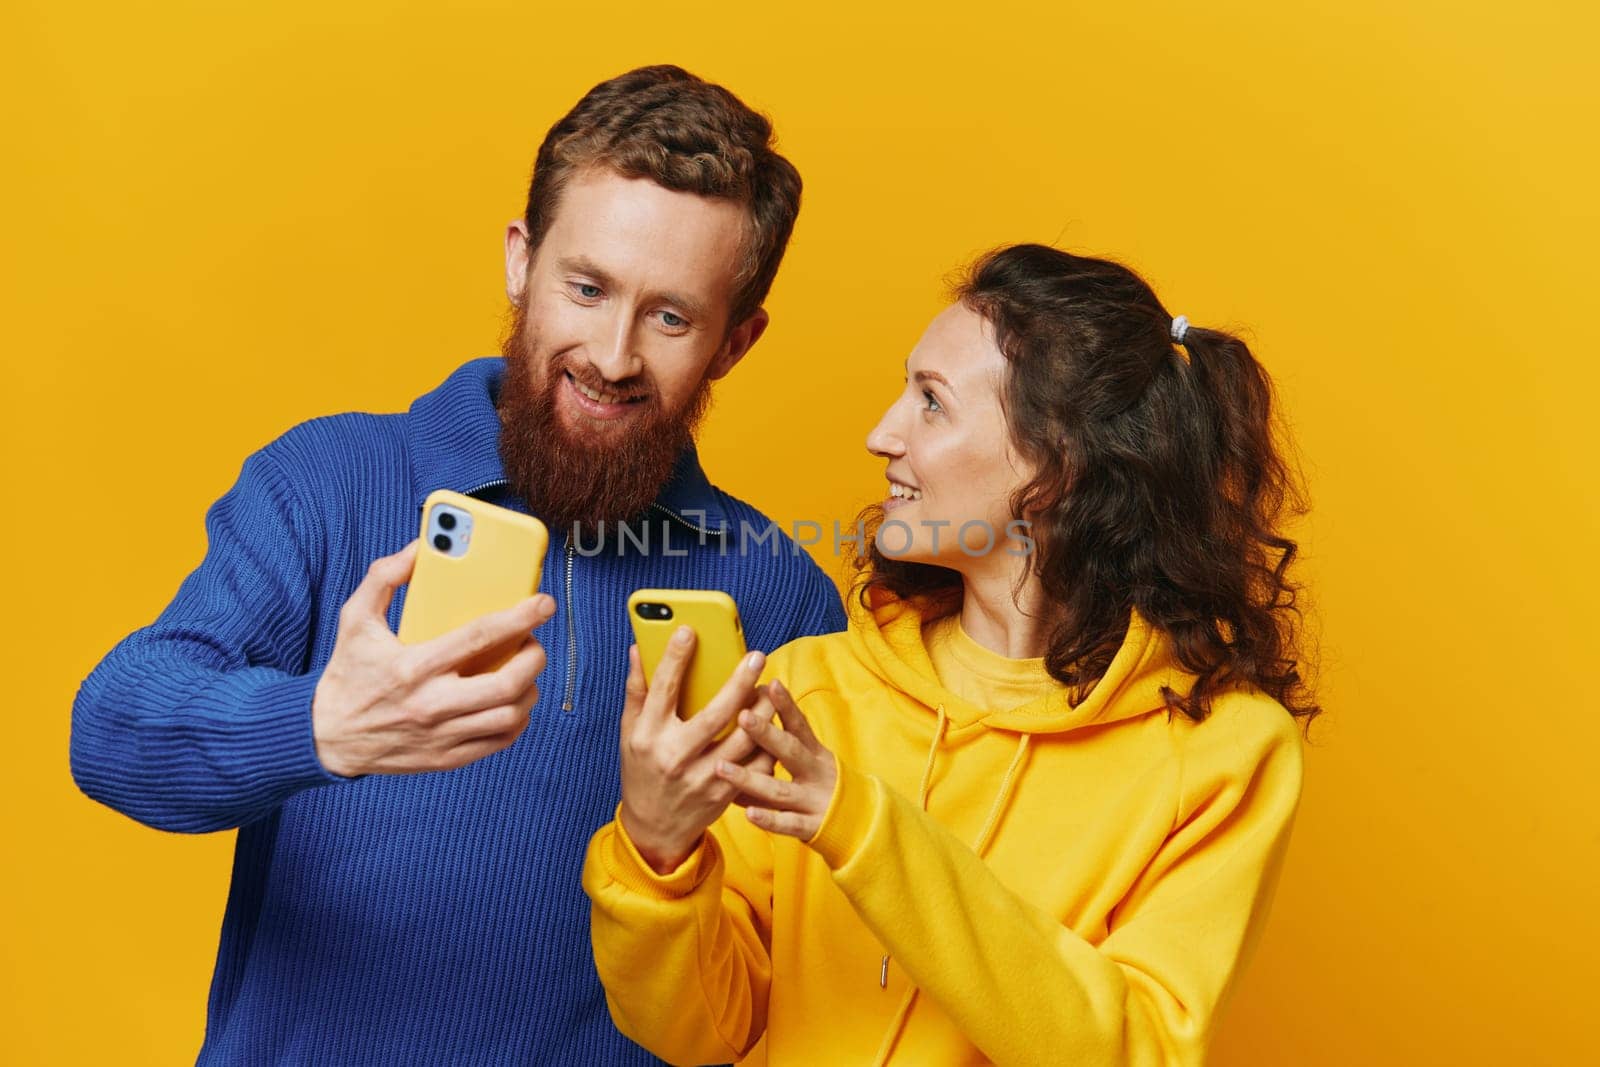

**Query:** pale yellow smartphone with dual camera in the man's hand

left=400, top=490, right=550, bottom=673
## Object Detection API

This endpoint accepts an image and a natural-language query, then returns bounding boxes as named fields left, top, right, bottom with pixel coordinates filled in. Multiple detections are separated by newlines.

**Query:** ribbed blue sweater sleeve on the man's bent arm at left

left=72, top=450, right=344, bottom=832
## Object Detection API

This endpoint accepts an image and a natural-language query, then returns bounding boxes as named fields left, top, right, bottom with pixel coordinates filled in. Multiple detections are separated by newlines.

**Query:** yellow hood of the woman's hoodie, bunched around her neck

left=848, top=590, right=1195, bottom=734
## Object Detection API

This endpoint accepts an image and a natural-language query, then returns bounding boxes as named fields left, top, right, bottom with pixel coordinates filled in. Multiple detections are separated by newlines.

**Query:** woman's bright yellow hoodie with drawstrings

left=584, top=598, right=1301, bottom=1067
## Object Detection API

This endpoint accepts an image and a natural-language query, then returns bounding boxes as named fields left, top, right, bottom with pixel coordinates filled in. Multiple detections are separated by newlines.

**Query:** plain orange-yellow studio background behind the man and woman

left=0, top=0, right=1600, bottom=1064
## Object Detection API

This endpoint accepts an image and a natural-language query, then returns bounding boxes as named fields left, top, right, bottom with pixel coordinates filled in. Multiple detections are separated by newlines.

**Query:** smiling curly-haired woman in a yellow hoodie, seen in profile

left=584, top=245, right=1318, bottom=1065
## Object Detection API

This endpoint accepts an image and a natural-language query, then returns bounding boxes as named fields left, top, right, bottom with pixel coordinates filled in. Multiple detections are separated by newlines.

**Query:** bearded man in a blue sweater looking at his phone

left=72, top=67, right=843, bottom=1064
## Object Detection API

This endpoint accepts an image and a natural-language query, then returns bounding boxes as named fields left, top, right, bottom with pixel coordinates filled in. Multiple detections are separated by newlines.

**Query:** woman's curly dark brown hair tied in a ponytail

left=856, top=245, right=1322, bottom=723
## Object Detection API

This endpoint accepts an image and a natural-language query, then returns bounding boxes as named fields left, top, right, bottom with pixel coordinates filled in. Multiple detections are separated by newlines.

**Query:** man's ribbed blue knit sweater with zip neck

left=72, top=358, right=845, bottom=1064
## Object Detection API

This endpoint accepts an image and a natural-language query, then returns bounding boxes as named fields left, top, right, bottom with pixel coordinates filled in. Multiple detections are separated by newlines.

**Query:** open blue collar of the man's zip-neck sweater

left=408, top=355, right=728, bottom=534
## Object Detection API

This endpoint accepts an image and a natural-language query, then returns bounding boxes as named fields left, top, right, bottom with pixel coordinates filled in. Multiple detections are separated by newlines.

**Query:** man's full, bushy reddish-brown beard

left=498, top=309, right=710, bottom=536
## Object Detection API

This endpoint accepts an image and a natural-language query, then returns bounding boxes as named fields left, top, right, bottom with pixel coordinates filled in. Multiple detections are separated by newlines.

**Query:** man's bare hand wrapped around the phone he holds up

left=312, top=541, right=556, bottom=777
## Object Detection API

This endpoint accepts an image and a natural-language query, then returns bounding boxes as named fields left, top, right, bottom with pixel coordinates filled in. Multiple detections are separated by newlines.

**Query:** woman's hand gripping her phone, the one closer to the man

left=621, top=625, right=776, bottom=873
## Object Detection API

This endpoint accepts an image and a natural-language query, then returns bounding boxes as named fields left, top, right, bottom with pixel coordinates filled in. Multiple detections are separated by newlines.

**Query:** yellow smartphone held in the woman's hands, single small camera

left=627, top=589, right=746, bottom=741
